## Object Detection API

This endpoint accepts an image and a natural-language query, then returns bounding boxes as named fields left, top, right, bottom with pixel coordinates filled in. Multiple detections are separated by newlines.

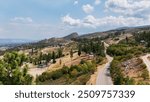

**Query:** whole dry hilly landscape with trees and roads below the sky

left=0, top=27, right=150, bottom=85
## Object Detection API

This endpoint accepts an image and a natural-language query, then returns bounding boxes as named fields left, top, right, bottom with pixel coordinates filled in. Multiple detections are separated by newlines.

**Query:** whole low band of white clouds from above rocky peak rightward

left=63, top=15, right=146, bottom=28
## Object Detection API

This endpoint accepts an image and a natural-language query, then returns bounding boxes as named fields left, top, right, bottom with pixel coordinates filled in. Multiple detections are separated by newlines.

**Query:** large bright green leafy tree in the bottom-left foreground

left=0, top=52, right=33, bottom=85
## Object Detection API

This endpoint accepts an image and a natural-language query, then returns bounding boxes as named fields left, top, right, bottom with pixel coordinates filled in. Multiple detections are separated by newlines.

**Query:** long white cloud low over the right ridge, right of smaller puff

left=83, top=15, right=144, bottom=28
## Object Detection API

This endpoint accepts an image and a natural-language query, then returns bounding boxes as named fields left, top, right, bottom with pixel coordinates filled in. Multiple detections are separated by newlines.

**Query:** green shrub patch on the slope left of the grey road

left=36, top=61, right=96, bottom=85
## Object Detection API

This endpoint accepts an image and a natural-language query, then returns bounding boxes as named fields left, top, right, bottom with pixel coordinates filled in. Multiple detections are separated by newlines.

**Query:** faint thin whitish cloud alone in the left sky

left=11, top=17, right=33, bottom=23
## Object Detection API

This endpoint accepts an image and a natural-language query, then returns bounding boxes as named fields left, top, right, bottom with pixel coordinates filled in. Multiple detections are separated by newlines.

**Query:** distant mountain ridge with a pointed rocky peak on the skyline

left=34, top=25, right=150, bottom=46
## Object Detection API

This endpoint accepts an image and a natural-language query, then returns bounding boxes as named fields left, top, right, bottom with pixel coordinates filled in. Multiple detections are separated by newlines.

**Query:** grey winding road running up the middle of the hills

left=96, top=42, right=113, bottom=85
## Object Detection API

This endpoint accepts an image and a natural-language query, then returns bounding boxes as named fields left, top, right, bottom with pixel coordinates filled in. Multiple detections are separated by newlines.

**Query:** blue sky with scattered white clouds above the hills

left=0, top=0, right=150, bottom=40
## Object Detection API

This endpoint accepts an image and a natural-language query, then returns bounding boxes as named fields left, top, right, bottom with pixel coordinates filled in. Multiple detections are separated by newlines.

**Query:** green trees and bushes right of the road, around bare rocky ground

left=107, top=37, right=149, bottom=85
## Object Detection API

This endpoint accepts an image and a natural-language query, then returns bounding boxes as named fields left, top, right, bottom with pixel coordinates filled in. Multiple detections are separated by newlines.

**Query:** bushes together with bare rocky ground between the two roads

left=107, top=36, right=149, bottom=85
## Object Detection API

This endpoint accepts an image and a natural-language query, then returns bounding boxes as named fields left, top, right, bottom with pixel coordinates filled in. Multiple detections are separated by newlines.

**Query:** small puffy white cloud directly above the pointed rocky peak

left=62, top=14, right=81, bottom=26
